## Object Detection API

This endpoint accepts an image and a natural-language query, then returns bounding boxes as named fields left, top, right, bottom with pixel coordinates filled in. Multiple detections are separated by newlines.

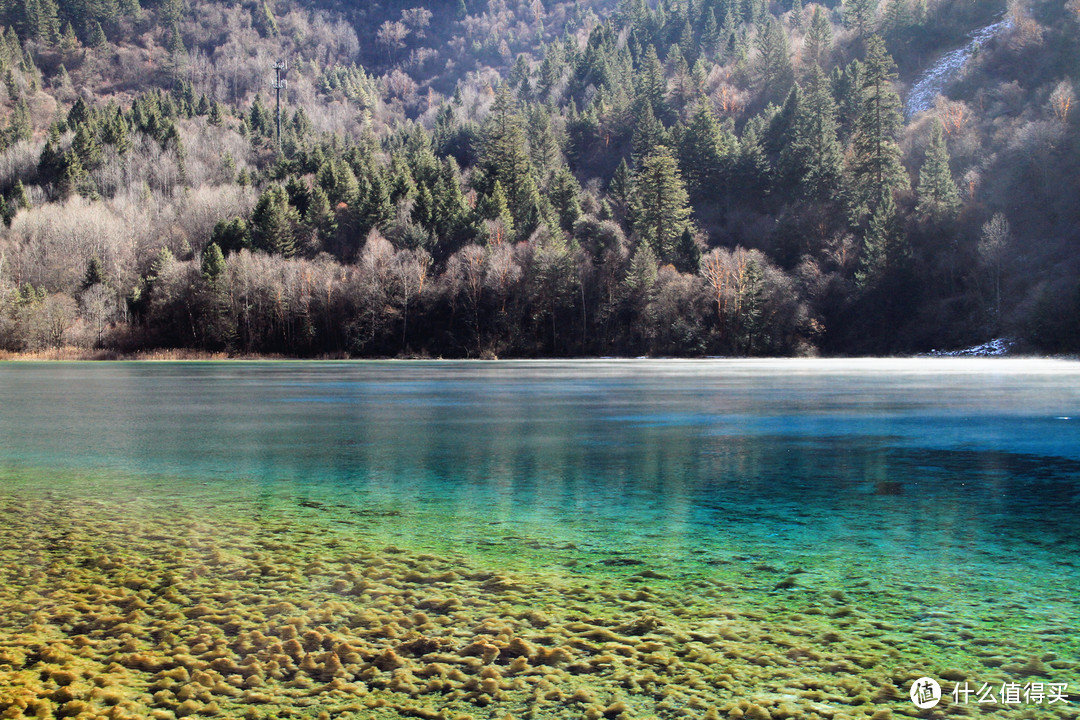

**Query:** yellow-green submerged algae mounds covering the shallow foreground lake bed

left=0, top=486, right=1078, bottom=720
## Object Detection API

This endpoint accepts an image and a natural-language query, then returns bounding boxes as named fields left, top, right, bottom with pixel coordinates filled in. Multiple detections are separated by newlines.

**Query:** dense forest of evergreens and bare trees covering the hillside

left=0, top=0, right=1080, bottom=357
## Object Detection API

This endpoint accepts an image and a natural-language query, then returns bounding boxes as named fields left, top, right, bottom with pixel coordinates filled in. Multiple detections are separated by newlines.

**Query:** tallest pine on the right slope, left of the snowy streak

left=850, top=36, right=908, bottom=217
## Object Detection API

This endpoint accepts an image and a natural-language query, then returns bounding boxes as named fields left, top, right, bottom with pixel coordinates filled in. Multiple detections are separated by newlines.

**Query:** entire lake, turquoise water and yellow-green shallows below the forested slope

left=0, top=358, right=1080, bottom=720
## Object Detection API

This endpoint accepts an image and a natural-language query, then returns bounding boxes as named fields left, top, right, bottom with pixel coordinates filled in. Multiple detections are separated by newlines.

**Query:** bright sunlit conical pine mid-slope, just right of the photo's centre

left=630, top=147, right=690, bottom=262
